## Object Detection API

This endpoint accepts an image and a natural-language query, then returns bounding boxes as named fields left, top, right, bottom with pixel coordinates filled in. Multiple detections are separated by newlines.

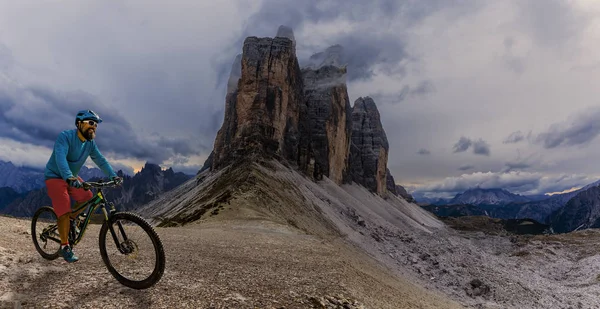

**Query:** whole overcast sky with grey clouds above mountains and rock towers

left=0, top=0, right=600, bottom=195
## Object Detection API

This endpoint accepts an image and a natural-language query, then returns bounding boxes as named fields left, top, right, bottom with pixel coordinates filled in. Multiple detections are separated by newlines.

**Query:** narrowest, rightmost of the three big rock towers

left=350, top=97, right=389, bottom=194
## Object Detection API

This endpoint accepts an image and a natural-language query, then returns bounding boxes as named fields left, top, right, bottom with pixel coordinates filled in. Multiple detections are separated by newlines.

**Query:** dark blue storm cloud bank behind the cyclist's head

left=0, top=82, right=202, bottom=162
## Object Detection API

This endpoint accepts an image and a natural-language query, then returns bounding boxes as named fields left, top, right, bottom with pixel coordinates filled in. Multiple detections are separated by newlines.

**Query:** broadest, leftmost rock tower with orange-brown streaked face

left=211, top=37, right=304, bottom=169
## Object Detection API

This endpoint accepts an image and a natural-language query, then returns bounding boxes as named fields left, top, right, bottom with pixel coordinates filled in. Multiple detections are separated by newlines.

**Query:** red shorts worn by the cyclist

left=46, top=177, right=92, bottom=217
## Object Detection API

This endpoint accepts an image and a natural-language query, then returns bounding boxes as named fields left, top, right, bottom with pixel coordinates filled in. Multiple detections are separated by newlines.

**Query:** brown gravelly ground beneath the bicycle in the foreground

left=0, top=217, right=462, bottom=309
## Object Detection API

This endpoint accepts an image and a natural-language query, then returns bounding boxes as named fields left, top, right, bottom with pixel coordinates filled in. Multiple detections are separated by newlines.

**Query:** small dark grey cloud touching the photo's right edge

left=535, top=107, right=600, bottom=148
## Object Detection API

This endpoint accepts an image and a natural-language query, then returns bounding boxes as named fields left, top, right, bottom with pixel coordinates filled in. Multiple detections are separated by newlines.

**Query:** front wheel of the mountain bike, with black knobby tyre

left=100, top=212, right=165, bottom=289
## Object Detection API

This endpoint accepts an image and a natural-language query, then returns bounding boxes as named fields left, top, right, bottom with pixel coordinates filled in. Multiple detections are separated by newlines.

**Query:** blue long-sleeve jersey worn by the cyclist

left=44, top=129, right=117, bottom=180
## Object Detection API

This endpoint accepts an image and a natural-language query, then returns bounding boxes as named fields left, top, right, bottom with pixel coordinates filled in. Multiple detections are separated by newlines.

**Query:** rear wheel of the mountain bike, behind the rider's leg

left=31, top=206, right=60, bottom=260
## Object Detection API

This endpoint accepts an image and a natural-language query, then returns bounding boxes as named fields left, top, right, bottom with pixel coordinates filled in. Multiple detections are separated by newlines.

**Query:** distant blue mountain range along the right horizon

left=416, top=181, right=600, bottom=232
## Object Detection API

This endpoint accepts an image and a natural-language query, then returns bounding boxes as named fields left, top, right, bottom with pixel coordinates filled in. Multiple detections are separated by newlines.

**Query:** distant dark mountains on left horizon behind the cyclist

left=0, top=162, right=193, bottom=217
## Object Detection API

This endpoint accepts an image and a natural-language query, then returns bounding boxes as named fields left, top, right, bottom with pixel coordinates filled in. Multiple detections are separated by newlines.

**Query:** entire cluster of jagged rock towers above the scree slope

left=207, top=27, right=408, bottom=195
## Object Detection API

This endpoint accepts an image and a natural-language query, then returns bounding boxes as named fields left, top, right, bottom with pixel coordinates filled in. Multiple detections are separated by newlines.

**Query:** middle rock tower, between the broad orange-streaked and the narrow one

left=299, top=66, right=352, bottom=184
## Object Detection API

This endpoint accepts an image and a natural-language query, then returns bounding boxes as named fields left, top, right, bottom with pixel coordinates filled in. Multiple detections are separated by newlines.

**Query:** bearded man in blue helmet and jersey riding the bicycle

left=44, top=110, right=122, bottom=263
